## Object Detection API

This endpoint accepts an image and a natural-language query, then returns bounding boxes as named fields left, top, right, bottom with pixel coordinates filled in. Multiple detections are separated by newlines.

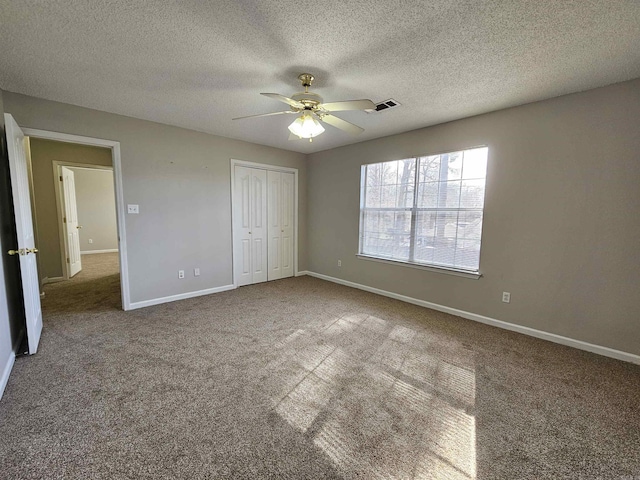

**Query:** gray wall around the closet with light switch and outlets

left=4, top=92, right=307, bottom=302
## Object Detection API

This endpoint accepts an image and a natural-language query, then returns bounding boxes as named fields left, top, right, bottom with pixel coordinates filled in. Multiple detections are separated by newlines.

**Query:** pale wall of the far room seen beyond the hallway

left=71, top=168, right=118, bottom=252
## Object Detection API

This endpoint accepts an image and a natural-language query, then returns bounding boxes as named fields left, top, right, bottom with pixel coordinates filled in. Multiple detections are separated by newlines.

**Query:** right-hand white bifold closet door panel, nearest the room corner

left=267, top=170, right=295, bottom=280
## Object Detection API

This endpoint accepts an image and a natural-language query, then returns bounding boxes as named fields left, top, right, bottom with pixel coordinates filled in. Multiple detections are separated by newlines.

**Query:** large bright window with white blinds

left=359, top=147, right=488, bottom=273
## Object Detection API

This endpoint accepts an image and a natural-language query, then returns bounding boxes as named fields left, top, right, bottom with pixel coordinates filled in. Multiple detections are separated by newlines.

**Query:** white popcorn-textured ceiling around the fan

left=0, top=0, right=640, bottom=153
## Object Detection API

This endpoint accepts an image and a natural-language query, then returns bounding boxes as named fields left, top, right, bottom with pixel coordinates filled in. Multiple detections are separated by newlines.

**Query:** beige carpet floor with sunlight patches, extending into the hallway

left=0, top=255, right=640, bottom=480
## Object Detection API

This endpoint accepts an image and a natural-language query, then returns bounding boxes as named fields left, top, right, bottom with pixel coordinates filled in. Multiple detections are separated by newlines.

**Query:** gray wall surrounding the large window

left=308, top=79, right=640, bottom=355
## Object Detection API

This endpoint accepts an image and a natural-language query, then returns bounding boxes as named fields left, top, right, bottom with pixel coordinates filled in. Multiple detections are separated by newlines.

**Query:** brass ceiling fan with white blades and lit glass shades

left=233, top=73, right=376, bottom=141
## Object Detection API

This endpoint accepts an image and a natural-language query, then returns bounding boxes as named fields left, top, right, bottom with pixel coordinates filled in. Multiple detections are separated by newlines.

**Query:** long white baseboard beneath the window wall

left=298, top=272, right=640, bottom=365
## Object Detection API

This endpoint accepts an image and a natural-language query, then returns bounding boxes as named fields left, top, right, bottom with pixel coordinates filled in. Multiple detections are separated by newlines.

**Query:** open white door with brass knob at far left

left=4, top=113, right=42, bottom=355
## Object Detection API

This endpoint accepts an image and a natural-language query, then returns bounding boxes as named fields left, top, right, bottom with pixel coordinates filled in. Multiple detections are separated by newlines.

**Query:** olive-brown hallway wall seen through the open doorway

left=28, top=139, right=112, bottom=279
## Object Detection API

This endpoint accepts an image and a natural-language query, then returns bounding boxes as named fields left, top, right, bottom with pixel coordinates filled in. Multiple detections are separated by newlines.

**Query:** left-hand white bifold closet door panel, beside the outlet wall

left=233, top=165, right=267, bottom=286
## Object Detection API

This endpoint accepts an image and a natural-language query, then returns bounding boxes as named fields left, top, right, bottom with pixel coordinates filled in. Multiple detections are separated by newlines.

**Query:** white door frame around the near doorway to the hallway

left=22, top=128, right=131, bottom=310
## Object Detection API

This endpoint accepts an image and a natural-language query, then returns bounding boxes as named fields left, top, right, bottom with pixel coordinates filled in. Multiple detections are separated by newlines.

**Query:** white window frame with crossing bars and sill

left=356, top=145, right=489, bottom=279
